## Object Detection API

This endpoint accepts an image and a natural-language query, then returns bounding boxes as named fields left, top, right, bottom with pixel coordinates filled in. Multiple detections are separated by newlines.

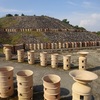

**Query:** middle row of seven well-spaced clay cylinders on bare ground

left=5, top=49, right=88, bottom=70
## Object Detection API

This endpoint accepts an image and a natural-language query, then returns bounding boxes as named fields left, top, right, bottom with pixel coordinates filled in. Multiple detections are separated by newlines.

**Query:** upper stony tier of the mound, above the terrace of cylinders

left=0, top=16, right=73, bottom=29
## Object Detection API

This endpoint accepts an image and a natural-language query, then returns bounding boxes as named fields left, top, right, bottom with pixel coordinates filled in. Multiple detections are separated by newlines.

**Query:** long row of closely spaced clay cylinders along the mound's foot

left=26, top=41, right=100, bottom=50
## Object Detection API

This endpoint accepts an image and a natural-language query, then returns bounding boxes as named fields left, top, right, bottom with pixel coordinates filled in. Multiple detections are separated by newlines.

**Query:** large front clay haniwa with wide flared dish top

left=69, top=70, right=98, bottom=100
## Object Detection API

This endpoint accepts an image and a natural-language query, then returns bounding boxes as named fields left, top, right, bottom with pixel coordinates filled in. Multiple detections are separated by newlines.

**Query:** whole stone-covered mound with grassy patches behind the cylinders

left=0, top=16, right=100, bottom=44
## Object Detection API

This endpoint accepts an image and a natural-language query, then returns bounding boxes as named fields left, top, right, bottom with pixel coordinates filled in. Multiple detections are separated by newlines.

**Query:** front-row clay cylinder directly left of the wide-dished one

left=42, top=74, right=61, bottom=100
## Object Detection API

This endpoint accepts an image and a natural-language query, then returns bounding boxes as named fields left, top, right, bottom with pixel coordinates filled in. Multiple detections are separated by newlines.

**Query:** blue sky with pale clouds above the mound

left=0, top=0, right=100, bottom=31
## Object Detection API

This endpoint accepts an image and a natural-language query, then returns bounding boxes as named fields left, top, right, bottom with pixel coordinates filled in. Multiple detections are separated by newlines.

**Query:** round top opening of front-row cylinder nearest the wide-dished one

left=42, top=74, right=61, bottom=84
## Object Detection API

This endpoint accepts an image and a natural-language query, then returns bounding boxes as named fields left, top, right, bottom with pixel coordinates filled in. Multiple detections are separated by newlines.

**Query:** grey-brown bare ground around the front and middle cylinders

left=0, top=49, right=100, bottom=100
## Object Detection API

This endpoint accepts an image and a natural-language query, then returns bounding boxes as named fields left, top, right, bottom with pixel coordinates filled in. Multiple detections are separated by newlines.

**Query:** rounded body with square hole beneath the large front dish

left=72, top=82, right=92, bottom=100
